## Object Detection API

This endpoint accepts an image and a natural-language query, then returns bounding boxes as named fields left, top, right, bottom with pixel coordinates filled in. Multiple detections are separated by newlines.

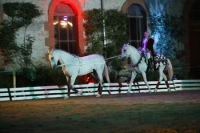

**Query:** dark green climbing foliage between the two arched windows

left=84, top=9, right=128, bottom=81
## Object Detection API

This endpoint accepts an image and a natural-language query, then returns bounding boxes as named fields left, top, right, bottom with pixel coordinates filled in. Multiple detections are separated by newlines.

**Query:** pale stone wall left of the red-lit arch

left=2, top=0, right=49, bottom=65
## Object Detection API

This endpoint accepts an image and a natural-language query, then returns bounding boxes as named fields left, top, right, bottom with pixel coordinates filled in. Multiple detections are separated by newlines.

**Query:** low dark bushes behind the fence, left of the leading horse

left=0, top=66, right=66, bottom=88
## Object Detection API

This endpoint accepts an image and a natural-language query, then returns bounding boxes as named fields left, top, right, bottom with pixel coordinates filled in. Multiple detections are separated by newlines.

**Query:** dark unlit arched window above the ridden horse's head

left=128, top=4, right=147, bottom=47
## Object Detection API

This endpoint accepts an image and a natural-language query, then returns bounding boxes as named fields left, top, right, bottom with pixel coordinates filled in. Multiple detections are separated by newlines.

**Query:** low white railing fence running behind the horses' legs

left=0, top=80, right=200, bottom=101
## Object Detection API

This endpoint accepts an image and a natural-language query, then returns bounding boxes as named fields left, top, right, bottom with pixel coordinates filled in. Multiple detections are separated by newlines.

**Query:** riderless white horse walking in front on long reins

left=48, top=49, right=110, bottom=97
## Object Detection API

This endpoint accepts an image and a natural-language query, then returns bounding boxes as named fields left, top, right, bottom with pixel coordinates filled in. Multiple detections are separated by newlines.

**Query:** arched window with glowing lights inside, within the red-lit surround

left=53, top=3, right=77, bottom=53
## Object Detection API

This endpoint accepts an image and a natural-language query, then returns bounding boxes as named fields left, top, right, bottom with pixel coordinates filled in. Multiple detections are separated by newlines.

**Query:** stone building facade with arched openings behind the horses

left=0, top=0, right=200, bottom=78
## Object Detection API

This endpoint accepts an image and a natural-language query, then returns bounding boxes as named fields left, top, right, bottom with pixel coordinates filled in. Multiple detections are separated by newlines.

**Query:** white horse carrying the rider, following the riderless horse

left=121, top=44, right=173, bottom=92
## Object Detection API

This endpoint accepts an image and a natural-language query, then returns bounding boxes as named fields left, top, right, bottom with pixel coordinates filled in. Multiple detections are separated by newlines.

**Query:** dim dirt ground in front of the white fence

left=0, top=91, right=200, bottom=133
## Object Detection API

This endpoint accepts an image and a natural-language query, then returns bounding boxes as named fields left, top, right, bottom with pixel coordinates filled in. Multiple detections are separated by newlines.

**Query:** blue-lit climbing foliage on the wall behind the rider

left=146, top=0, right=183, bottom=59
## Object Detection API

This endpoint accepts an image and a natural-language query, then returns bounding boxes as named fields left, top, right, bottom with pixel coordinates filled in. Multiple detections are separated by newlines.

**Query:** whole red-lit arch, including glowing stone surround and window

left=48, top=0, right=85, bottom=55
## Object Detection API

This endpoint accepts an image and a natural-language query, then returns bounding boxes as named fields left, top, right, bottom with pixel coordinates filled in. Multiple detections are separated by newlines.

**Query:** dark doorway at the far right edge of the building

left=188, top=0, right=200, bottom=79
